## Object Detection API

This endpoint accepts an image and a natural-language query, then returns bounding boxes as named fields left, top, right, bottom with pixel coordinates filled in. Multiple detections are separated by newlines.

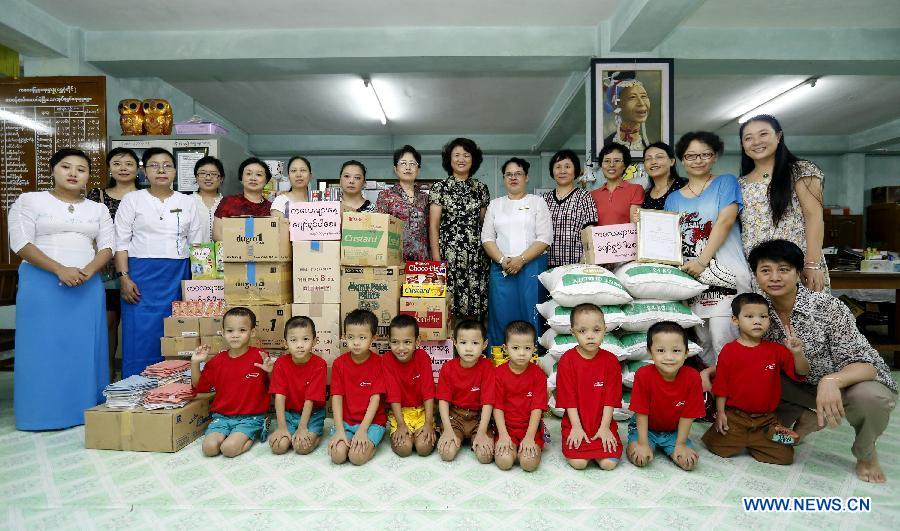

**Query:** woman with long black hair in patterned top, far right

left=739, top=114, right=831, bottom=291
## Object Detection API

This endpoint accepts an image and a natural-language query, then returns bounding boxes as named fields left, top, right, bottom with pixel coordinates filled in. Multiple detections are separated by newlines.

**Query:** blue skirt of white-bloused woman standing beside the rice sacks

left=488, top=254, right=547, bottom=348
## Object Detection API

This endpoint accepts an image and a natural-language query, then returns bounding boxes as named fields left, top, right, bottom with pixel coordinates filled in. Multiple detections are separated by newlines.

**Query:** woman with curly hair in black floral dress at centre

left=428, top=138, right=491, bottom=321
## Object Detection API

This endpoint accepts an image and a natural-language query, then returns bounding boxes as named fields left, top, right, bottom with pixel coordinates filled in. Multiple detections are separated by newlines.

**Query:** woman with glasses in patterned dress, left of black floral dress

left=375, top=145, right=429, bottom=260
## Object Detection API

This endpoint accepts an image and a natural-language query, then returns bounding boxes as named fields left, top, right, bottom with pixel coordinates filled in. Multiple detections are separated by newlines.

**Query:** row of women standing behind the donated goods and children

left=9, top=115, right=896, bottom=486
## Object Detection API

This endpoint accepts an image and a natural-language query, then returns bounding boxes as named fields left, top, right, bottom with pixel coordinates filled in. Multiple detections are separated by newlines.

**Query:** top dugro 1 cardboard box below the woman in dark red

left=222, top=217, right=291, bottom=262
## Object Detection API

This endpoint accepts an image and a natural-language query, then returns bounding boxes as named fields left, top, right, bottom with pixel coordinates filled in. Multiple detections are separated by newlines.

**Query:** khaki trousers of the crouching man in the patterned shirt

left=775, top=375, right=897, bottom=461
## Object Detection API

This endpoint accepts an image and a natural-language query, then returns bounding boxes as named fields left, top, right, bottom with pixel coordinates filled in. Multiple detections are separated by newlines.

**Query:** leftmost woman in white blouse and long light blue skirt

left=9, top=149, right=115, bottom=430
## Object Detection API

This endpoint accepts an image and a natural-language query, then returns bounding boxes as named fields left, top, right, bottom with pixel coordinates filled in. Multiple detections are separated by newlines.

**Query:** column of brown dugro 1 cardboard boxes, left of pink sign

left=221, top=217, right=293, bottom=355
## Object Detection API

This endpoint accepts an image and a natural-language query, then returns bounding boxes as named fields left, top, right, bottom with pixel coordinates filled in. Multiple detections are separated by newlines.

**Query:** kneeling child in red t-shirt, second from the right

left=625, top=321, right=706, bottom=470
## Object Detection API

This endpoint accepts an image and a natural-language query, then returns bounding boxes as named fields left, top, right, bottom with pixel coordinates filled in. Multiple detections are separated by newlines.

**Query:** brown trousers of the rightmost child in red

left=703, top=407, right=794, bottom=465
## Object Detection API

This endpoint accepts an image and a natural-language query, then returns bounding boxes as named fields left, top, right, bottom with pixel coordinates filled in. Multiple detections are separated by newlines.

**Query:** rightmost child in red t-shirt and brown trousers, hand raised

left=703, top=293, right=809, bottom=465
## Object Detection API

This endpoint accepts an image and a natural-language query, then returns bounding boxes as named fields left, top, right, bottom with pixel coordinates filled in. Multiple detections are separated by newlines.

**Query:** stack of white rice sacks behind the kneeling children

left=537, top=262, right=707, bottom=421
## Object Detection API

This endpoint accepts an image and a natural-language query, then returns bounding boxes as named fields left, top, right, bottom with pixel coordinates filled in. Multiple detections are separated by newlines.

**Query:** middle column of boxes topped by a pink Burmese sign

left=289, top=201, right=341, bottom=370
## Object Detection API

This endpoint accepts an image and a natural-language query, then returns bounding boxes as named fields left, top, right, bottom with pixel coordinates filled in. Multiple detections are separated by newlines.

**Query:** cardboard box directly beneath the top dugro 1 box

left=225, top=262, right=294, bottom=306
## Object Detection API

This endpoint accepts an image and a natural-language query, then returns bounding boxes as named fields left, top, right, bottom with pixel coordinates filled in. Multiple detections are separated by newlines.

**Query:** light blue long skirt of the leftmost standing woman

left=13, top=262, right=109, bottom=431
